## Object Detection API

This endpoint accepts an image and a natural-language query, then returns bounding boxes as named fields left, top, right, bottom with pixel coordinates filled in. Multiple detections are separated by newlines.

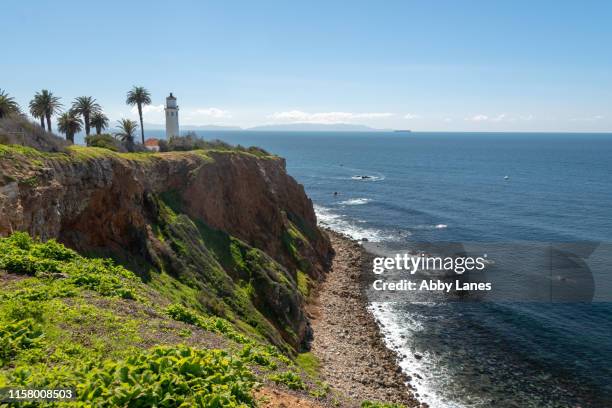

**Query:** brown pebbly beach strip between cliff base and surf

left=308, top=230, right=427, bottom=407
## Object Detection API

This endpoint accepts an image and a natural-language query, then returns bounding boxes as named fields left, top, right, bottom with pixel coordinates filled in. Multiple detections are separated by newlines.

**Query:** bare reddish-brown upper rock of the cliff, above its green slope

left=0, top=152, right=330, bottom=278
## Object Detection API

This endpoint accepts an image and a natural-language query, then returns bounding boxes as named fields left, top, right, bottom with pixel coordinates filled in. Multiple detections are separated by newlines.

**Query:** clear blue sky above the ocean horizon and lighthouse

left=0, top=0, right=612, bottom=131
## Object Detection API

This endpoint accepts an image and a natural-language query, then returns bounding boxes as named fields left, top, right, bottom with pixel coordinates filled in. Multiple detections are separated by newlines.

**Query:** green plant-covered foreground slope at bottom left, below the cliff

left=0, top=233, right=328, bottom=407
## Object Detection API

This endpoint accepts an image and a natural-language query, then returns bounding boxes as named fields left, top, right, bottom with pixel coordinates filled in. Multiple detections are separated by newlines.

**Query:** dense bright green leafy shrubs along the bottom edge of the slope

left=9, top=346, right=255, bottom=408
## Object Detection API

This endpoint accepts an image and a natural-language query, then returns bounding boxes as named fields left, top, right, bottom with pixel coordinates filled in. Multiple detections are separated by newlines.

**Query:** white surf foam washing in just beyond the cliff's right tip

left=314, top=204, right=410, bottom=242
